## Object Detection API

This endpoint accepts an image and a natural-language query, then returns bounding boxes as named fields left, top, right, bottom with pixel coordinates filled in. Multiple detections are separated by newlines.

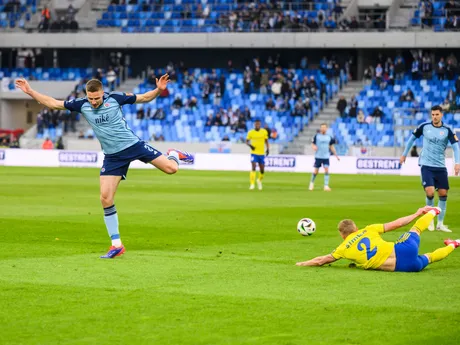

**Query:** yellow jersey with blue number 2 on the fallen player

left=331, top=224, right=395, bottom=269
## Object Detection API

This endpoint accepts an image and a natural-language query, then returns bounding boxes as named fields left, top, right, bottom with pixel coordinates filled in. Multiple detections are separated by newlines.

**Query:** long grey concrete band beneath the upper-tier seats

left=0, top=31, right=460, bottom=49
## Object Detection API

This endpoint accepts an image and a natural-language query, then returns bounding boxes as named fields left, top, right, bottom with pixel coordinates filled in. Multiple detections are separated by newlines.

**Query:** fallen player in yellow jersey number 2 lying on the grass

left=297, top=206, right=460, bottom=272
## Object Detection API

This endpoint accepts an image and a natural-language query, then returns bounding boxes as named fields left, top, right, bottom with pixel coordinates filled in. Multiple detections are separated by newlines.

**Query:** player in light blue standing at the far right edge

left=400, top=105, right=460, bottom=232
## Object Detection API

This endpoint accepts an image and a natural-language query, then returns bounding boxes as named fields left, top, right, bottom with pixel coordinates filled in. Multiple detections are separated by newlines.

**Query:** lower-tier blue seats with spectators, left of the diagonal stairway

left=33, top=68, right=346, bottom=144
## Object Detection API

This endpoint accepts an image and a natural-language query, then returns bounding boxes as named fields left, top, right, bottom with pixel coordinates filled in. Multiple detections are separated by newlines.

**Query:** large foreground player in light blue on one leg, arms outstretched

left=16, top=74, right=193, bottom=259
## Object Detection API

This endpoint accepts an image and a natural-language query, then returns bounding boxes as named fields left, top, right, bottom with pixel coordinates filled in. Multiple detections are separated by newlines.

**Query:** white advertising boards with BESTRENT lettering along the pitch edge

left=0, top=149, right=453, bottom=176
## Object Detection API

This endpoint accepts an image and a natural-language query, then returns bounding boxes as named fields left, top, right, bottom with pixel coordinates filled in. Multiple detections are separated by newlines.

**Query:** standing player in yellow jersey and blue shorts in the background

left=246, top=119, right=270, bottom=190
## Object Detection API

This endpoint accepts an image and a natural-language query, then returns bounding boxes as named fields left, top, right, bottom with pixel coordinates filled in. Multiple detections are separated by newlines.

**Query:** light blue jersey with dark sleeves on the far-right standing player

left=403, top=122, right=458, bottom=168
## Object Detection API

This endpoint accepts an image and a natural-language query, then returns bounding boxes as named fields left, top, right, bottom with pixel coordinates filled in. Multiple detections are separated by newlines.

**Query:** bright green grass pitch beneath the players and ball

left=0, top=167, right=460, bottom=345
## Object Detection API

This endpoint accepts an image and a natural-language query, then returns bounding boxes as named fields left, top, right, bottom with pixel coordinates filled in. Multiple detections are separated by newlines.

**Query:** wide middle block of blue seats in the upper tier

left=97, top=0, right=343, bottom=33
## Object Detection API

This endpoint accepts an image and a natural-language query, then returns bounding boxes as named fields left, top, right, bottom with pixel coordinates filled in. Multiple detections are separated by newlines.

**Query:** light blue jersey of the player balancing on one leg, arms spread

left=64, top=92, right=140, bottom=154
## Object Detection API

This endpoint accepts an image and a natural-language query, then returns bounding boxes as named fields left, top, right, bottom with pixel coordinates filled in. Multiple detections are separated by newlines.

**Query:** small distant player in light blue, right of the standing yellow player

left=308, top=123, right=340, bottom=192
